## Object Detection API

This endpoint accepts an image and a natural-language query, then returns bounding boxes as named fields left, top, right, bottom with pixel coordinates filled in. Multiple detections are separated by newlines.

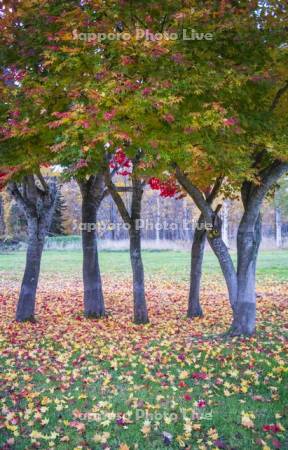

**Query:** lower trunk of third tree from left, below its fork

left=130, top=227, right=149, bottom=324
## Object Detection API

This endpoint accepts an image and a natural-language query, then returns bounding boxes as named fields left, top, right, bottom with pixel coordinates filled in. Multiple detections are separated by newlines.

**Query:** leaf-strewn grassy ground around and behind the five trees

left=0, top=251, right=288, bottom=450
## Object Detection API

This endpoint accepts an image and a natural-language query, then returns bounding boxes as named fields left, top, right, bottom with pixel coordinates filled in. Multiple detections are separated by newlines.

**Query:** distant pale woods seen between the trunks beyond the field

left=0, top=179, right=288, bottom=248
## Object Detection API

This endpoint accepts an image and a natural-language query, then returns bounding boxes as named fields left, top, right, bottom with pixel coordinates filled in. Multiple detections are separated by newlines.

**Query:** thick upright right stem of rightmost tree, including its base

left=230, top=214, right=262, bottom=336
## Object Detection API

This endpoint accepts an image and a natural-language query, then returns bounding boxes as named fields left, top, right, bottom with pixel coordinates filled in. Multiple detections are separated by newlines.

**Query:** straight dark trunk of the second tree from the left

left=79, top=175, right=105, bottom=318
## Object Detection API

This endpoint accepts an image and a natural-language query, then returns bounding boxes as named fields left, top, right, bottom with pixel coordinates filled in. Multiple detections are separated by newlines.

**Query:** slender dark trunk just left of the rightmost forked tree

left=187, top=218, right=206, bottom=318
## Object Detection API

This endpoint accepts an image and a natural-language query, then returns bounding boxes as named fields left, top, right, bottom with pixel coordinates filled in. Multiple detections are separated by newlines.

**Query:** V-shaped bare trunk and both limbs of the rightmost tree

left=175, top=163, right=288, bottom=336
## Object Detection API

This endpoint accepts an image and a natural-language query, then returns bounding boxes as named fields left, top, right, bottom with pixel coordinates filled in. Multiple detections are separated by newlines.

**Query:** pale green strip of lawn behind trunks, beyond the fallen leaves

left=0, top=250, right=288, bottom=281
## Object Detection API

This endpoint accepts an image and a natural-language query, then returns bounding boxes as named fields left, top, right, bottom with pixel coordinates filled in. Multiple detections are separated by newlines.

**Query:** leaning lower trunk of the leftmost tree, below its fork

left=16, top=217, right=48, bottom=322
